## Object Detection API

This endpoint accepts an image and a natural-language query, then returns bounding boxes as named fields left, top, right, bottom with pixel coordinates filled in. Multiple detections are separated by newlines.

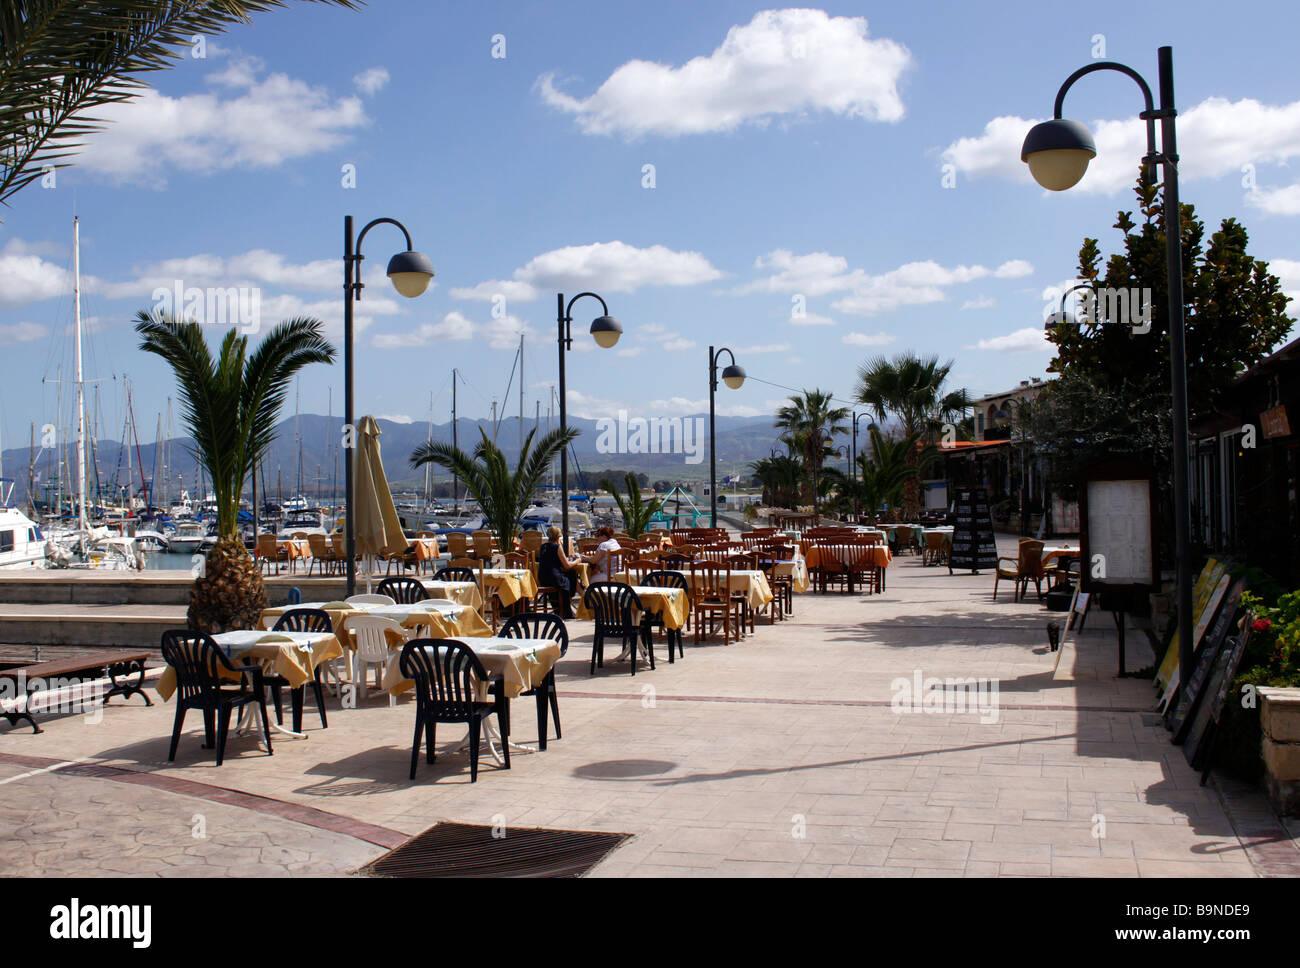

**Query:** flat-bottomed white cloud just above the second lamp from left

left=451, top=242, right=722, bottom=300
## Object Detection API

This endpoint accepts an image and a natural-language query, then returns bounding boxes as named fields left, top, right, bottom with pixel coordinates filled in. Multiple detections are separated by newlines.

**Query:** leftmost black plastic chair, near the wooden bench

left=163, top=629, right=273, bottom=767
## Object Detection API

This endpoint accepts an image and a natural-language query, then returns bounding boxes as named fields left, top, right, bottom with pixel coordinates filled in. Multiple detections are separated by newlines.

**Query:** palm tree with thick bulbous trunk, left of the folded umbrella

left=135, top=311, right=334, bottom=633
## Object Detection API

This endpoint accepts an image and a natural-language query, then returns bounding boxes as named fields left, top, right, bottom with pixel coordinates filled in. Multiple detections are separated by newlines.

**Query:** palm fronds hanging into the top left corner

left=0, top=0, right=356, bottom=209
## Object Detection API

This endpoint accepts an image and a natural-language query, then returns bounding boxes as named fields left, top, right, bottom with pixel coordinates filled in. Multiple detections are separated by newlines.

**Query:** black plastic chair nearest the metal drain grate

left=398, top=638, right=510, bottom=783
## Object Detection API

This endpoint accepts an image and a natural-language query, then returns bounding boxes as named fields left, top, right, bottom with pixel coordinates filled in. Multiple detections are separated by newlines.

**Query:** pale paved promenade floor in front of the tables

left=0, top=543, right=1300, bottom=877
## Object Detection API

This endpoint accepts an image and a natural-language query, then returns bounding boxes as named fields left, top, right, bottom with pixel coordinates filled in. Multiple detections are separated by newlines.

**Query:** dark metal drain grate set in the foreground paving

left=358, top=824, right=631, bottom=877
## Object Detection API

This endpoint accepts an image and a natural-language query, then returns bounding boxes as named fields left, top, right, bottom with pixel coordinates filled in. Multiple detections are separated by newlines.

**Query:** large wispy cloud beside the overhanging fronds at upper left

left=75, top=61, right=369, bottom=187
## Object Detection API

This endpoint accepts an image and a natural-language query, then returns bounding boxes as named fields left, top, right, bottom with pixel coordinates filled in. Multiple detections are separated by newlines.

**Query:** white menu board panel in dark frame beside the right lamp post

left=1084, top=479, right=1153, bottom=585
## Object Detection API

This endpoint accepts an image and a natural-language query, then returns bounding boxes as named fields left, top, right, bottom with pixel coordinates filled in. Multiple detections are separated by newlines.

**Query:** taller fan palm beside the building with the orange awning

left=857, top=352, right=971, bottom=518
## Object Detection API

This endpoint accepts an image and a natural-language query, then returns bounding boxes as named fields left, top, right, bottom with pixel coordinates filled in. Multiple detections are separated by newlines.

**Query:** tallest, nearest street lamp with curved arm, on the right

left=1021, top=47, right=1195, bottom=687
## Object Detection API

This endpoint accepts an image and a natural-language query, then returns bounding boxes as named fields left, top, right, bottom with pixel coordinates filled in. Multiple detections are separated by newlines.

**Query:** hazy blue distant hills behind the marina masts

left=0, top=413, right=779, bottom=502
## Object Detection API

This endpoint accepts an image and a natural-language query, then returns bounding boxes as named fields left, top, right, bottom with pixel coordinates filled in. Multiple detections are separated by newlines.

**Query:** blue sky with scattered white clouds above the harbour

left=0, top=0, right=1300, bottom=447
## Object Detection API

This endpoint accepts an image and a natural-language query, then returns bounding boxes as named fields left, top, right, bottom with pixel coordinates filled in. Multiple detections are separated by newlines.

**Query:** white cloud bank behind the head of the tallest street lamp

left=943, top=97, right=1300, bottom=203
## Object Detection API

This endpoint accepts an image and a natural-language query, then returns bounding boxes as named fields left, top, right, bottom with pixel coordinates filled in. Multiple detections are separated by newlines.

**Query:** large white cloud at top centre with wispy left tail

left=538, top=9, right=911, bottom=138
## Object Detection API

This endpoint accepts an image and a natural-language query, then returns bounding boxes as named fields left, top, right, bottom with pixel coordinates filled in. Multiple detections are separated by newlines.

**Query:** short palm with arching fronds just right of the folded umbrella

left=411, top=427, right=579, bottom=551
